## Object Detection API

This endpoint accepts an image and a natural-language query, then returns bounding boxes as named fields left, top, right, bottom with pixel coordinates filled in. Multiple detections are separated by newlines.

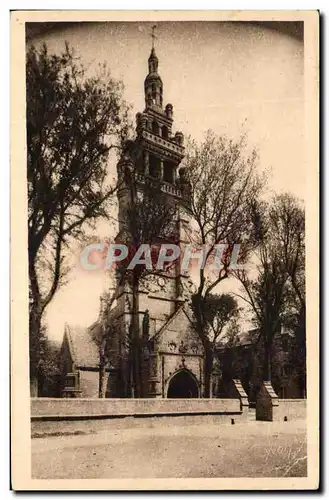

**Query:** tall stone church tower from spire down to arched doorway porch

left=109, top=46, right=203, bottom=398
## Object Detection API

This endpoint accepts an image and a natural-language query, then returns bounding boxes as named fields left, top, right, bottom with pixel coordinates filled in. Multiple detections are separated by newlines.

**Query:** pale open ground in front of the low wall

left=32, top=419, right=307, bottom=479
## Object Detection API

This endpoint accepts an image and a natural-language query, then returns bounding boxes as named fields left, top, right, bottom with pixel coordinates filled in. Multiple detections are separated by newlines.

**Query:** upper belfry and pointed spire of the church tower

left=117, top=26, right=188, bottom=250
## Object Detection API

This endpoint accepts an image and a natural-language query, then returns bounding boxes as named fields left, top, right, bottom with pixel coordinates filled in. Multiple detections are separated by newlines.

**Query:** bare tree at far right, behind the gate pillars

left=236, top=194, right=305, bottom=380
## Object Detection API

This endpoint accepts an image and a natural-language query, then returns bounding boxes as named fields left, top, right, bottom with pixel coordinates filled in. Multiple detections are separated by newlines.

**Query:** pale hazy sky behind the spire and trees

left=30, top=22, right=305, bottom=340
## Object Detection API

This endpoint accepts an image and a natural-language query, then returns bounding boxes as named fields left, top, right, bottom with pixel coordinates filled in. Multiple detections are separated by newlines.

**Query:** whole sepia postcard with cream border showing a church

left=11, top=11, right=319, bottom=490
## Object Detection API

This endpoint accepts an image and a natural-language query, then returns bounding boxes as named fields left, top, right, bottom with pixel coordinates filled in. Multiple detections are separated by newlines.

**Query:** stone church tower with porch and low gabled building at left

left=61, top=45, right=208, bottom=398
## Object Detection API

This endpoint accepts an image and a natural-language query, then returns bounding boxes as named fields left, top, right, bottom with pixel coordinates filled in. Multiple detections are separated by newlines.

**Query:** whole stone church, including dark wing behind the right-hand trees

left=60, top=40, right=304, bottom=400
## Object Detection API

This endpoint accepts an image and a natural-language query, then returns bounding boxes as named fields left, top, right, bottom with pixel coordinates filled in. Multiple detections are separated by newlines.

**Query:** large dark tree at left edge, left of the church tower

left=26, top=45, right=129, bottom=392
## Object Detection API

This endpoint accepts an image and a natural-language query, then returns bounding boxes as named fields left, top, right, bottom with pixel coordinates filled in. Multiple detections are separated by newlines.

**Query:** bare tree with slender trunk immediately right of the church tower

left=181, top=132, right=264, bottom=397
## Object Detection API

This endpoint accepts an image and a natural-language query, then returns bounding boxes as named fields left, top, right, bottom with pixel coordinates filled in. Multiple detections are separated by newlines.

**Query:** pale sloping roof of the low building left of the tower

left=65, top=323, right=101, bottom=368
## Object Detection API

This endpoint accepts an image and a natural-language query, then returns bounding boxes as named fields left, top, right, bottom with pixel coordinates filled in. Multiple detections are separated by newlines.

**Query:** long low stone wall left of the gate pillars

left=31, top=398, right=244, bottom=422
